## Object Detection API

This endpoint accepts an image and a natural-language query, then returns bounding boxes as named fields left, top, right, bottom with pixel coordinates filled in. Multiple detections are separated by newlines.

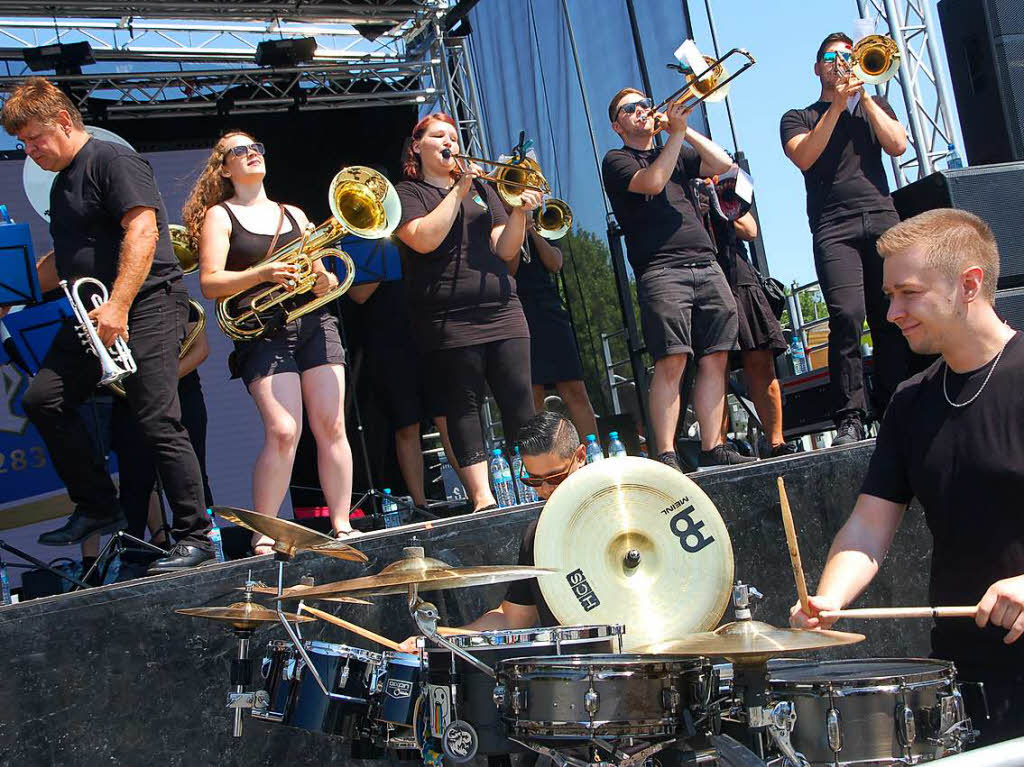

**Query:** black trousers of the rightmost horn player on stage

left=813, top=211, right=910, bottom=417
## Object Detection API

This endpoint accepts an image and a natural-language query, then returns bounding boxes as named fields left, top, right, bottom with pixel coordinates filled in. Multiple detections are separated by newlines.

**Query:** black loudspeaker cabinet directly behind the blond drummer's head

left=892, top=163, right=1024, bottom=288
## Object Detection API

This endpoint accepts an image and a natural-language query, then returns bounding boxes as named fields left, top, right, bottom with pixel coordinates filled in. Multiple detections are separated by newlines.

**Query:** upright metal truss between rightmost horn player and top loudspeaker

left=857, top=0, right=964, bottom=186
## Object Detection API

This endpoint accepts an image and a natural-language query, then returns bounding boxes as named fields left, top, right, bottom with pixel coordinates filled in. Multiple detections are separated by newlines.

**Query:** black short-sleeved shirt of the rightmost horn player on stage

left=779, top=95, right=896, bottom=230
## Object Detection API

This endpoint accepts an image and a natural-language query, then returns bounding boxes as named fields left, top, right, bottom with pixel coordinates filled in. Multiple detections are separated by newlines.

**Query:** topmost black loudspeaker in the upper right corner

left=939, top=0, right=1024, bottom=165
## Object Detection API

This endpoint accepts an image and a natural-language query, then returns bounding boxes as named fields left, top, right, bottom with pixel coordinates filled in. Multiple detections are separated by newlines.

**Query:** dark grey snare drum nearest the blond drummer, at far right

left=768, top=658, right=971, bottom=765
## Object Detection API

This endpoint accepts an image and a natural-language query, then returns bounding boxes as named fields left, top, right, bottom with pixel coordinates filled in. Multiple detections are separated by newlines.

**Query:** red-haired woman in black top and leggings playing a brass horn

left=395, top=113, right=541, bottom=511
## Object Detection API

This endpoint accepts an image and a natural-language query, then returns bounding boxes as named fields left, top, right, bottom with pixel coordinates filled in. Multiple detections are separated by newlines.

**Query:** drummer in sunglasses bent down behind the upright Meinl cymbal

left=401, top=411, right=587, bottom=652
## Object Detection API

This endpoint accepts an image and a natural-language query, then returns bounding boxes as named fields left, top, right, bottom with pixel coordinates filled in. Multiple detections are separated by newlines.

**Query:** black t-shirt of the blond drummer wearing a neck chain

left=861, top=331, right=1024, bottom=671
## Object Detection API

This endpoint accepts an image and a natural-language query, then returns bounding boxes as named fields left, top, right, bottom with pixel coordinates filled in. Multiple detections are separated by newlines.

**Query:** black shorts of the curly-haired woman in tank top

left=231, top=309, right=345, bottom=388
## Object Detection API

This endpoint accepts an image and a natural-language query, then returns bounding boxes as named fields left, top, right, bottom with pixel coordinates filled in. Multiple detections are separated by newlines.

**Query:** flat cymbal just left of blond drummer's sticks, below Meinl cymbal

left=637, top=621, right=864, bottom=663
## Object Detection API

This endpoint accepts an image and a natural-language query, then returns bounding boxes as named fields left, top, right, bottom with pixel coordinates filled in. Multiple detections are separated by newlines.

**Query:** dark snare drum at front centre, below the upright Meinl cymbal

left=495, top=654, right=712, bottom=742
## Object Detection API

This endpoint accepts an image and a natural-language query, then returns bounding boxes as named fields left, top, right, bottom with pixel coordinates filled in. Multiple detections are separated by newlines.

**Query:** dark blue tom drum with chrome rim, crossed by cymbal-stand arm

left=285, top=641, right=381, bottom=735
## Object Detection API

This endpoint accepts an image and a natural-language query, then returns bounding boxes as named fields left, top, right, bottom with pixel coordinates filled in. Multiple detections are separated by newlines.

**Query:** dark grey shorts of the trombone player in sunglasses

left=637, top=262, right=739, bottom=359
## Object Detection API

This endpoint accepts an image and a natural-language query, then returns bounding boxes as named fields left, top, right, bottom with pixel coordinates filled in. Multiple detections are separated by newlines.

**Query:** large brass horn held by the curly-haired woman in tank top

left=216, top=165, right=401, bottom=341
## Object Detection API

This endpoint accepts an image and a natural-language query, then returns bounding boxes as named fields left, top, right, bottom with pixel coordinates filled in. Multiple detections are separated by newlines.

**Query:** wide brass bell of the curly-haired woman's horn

left=329, top=165, right=401, bottom=240
